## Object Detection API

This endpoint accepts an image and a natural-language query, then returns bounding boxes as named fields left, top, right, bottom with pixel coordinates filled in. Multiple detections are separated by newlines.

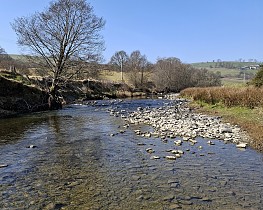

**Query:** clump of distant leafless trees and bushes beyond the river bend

left=109, top=50, right=221, bottom=92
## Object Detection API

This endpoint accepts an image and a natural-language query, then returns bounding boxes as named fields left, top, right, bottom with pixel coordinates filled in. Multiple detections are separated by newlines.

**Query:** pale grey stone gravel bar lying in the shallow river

left=110, top=96, right=250, bottom=160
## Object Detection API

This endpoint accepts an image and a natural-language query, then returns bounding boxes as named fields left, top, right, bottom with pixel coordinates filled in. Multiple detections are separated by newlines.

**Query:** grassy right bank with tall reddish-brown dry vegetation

left=181, top=87, right=263, bottom=151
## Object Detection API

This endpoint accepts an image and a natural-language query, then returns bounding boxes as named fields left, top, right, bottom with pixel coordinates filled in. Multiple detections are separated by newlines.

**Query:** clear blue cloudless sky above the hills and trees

left=0, top=0, right=263, bottom=63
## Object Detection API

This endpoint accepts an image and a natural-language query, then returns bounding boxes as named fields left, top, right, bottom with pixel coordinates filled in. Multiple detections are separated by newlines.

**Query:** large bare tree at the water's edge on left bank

left=12, top=0, right=105, bottom=109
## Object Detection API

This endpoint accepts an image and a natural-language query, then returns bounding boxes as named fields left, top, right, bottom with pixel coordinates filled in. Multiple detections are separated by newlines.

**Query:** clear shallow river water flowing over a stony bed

left=0, top=99, right=263, bottom=209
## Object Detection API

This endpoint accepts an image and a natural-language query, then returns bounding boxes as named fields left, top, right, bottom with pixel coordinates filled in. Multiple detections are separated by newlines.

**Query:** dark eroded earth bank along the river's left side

left=0, top=73, right=145, bottom=118
